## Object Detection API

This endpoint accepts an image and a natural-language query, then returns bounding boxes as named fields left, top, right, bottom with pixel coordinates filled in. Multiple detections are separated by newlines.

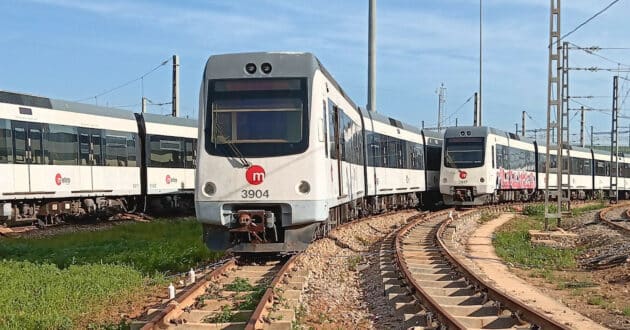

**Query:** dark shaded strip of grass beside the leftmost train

left=0, top=219, right=221, bottom=275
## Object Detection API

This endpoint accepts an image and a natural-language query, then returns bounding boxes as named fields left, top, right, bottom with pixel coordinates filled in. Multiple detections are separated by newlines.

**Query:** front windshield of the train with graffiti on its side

left=444, top=137, right=485, bottom=168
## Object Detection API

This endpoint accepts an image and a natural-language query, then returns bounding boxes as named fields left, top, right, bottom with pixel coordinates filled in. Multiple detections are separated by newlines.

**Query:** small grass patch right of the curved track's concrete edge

left=493, top=216, right=579, bottom=269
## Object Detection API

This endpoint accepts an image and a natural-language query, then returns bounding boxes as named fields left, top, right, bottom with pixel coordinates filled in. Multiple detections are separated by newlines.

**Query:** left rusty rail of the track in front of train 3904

left=142, top=258, right=236, bottom=330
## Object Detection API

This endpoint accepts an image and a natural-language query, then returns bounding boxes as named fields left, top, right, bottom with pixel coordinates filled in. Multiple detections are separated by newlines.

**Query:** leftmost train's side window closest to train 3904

left=149, top=135, right=184, bottom=168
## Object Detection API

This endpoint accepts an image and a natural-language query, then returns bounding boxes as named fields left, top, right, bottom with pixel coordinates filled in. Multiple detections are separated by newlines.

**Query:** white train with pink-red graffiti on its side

left=440, top=127, right=630, bottom=205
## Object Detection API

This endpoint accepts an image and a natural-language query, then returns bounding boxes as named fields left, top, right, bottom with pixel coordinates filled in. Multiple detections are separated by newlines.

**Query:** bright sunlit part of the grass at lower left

left=0, top=260, right=150, bottom=329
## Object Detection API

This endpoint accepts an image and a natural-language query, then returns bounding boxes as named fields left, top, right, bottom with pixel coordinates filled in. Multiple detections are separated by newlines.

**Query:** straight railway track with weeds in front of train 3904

left=137, top=255, right=305, bottom=330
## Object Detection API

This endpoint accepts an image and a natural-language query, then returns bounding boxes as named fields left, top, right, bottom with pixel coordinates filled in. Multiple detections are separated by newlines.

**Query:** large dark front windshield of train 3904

left=205, top=78, right=308, bottom=157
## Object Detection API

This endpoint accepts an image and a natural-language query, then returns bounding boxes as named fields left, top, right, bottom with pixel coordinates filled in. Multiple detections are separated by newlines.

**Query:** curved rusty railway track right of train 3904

left=380, top=207, right=568, bottom=329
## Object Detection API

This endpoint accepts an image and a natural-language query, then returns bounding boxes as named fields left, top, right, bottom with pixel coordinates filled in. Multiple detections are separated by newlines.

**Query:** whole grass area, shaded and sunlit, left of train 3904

left=0, top=218, right=222, bottom=329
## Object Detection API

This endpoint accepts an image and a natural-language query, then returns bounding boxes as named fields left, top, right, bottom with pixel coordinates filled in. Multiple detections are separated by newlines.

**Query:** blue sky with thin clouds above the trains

left=0, top=0, right=630, bottom=143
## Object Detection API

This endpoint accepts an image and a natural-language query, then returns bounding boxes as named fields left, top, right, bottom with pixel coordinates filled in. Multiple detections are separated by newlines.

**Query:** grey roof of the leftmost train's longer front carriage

left=0, top=91, right=135, bottom=120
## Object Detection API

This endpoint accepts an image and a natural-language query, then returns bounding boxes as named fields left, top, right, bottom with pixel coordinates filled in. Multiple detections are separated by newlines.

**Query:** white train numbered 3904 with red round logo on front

left=195, top=53, right=441, bottom=252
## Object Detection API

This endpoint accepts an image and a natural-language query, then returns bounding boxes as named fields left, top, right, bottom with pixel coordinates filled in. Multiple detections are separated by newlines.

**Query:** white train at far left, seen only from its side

left=0, top=91, right=197, bottom=224
